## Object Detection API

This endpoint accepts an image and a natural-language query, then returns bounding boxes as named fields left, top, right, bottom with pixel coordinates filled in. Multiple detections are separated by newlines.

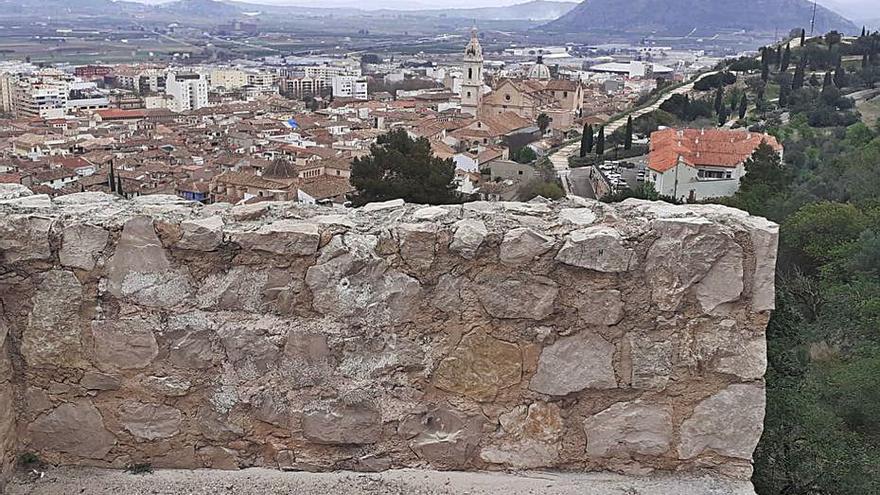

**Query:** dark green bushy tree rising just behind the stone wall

left=351, top=129, right=461, bottom=205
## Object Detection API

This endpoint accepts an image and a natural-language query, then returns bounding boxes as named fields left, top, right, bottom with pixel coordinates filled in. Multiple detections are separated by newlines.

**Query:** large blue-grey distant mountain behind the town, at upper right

left=542, top=0, right=860, bottom=36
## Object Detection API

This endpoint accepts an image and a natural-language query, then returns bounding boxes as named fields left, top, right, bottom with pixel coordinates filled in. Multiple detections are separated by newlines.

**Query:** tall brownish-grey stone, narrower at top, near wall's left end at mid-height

left=21, top=270, right=83, bottom=367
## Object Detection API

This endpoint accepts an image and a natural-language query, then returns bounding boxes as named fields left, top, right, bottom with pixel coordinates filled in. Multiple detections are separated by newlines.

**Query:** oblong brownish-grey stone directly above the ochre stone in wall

left=474, top=274, right=559, bottom=320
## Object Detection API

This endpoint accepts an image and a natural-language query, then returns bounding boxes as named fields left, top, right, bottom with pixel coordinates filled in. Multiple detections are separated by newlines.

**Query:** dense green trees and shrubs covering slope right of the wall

left=725, top=33, right=880, bottom=495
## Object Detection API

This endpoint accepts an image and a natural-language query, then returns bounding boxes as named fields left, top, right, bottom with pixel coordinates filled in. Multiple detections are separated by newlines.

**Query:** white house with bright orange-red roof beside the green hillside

left=647, top=129, right=783, bottom=201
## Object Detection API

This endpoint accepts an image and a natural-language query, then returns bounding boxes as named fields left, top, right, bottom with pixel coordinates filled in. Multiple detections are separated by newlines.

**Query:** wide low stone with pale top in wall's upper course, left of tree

left=232, top=220, right=321, bottom=256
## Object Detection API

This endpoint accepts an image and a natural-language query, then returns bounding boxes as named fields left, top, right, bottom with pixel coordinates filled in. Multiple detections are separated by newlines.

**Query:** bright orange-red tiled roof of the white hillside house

left=648, top=129, right=782, bottom=172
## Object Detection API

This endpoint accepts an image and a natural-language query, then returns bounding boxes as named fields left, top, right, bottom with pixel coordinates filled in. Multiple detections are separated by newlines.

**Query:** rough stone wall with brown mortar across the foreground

left=0, top=188, right=777, bottom=478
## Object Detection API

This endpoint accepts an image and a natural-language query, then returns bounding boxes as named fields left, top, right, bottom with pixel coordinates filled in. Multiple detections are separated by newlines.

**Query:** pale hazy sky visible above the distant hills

left=136, top=0, right=880, bottom=18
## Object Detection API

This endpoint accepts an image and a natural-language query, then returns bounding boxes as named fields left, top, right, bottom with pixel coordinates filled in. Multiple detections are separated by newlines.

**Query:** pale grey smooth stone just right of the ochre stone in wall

left=529, top=332, right=617, bottom=395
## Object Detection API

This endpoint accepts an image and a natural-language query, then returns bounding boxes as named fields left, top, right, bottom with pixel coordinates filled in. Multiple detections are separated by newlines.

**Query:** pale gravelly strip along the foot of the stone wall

left=7, top=468, right=755, bottom=495
